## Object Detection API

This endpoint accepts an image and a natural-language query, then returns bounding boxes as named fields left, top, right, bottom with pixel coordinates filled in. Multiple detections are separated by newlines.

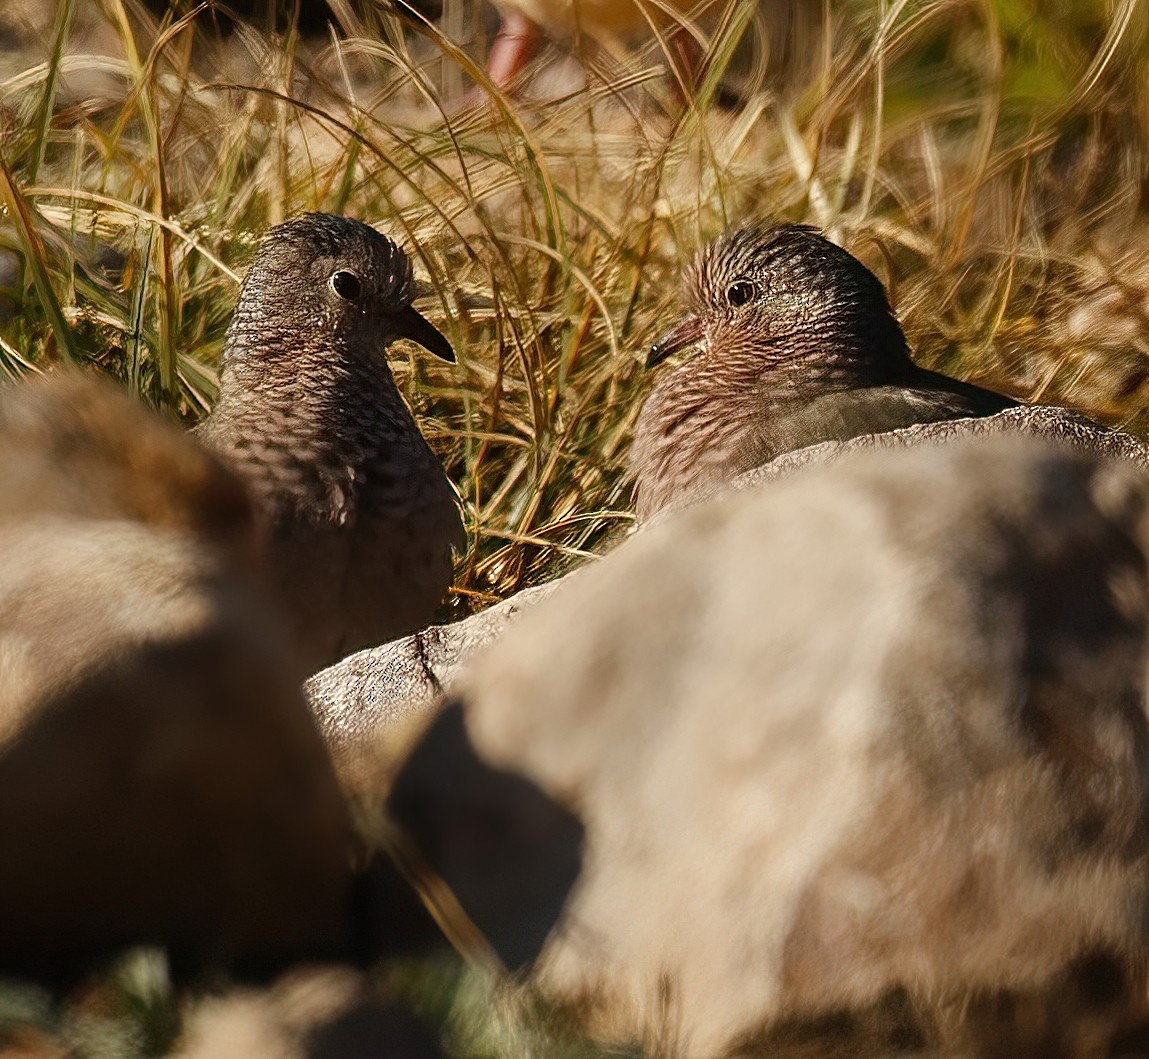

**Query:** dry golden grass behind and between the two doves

left=0, top=0, right=1149, bottom=1056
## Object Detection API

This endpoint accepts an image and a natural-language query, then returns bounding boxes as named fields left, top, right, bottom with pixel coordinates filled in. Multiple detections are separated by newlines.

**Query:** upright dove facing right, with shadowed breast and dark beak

left=196, top=214, right=466, bottom=675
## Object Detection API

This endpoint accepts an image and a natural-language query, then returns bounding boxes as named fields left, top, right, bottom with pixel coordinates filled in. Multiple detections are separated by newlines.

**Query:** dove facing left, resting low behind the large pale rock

left=630, top=222, right=1018, bottom=520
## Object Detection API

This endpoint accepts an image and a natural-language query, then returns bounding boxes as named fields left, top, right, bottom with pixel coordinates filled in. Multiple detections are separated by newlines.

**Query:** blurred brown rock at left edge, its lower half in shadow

left=0, top=376, right=349, bottom=980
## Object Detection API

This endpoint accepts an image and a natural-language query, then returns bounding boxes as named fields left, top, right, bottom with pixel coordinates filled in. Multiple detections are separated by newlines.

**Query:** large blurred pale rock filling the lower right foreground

left=391, top=439, right=1149, bottom=1056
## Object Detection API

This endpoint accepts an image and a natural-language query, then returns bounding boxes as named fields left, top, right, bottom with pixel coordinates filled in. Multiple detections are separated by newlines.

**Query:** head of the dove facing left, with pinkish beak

left=647, top=224, right=908, bottom=381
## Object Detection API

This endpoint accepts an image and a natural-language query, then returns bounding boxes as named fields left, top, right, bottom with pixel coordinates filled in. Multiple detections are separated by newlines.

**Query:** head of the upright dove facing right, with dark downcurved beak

left=229, top=214, right=455, bottom=362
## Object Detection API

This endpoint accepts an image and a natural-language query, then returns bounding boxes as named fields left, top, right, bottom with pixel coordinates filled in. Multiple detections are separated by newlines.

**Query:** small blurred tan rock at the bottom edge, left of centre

left=175, top=966, right=445, bottom=1059
